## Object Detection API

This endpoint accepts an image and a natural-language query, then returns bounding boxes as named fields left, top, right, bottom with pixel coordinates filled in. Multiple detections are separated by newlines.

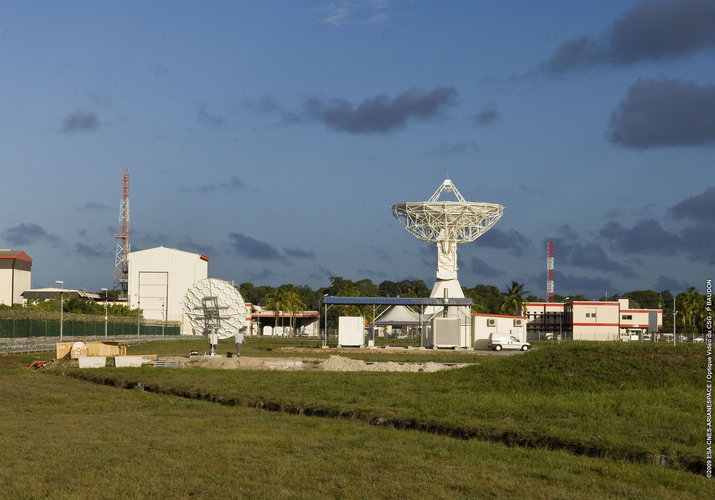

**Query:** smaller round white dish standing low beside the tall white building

left=183, top=278, right=251, bottom=339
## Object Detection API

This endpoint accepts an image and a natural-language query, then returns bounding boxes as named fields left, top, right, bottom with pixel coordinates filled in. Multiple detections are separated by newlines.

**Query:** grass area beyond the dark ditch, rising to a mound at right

left=56, top=343, right=704, bottom=468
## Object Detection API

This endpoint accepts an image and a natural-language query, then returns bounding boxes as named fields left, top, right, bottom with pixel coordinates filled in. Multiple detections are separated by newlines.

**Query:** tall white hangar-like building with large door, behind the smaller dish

left=127, top=246, right=209, bottom=334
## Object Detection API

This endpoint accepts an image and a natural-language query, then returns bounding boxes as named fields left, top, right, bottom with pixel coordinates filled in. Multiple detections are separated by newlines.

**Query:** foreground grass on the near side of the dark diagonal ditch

left=0, top=370, right=712, bottom=499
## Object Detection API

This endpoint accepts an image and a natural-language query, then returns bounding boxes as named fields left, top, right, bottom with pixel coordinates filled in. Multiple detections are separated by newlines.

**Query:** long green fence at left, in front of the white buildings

left=0, top=319, right=181, bottom=338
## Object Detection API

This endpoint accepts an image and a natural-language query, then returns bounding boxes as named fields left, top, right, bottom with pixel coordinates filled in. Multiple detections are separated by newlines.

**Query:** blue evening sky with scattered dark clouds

left=0, top=0, right=715, bottom=298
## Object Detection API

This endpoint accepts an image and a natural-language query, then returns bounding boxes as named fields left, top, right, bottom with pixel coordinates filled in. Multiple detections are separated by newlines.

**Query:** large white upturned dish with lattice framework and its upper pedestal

left=392, top=179, right=504, bottom=280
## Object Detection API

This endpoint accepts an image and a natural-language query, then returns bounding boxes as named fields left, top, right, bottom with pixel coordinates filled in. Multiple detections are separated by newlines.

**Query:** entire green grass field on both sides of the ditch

left=0, top=339, right=715, bottom=498
